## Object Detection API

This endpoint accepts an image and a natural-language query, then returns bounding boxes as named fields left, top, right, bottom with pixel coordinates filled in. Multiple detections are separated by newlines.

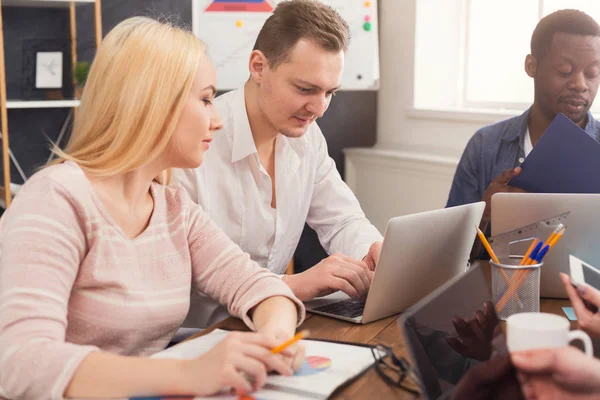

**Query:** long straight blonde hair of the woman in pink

left=52, top=17, right=205, bottom=184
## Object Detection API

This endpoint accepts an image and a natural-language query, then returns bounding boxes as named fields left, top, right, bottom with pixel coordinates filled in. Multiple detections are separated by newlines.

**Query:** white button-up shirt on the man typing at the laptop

left=174, top=89, right=382, bottom=327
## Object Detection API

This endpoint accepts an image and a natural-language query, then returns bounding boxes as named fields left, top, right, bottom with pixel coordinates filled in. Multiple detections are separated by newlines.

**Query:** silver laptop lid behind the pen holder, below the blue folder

left=492, top=193, right=600, bottom=298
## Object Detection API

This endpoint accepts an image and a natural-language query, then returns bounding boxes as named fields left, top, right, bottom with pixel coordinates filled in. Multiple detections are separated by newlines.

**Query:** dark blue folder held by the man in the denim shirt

left=509, top=114, right=600, bottom=193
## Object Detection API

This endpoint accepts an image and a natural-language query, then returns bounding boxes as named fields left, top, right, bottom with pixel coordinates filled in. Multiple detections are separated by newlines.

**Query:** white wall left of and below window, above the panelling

left=376, top=0, right=512, bottom=158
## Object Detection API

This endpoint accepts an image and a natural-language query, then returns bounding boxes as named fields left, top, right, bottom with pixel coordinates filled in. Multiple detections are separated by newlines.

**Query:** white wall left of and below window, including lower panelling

left=345, top=0, right=515, bottom=227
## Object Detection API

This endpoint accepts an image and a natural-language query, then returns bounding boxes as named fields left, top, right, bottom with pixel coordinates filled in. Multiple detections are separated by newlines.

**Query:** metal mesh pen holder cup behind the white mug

left=490, top=258, right=544, bottom=320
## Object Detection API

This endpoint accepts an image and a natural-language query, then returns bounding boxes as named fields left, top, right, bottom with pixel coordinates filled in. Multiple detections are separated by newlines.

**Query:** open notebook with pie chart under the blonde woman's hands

left=143, top=329, right=375, bottom=400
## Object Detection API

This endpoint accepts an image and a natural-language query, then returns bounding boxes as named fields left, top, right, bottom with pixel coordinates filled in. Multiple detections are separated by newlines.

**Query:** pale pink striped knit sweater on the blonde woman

left=0, top=162, right=304, bottom=399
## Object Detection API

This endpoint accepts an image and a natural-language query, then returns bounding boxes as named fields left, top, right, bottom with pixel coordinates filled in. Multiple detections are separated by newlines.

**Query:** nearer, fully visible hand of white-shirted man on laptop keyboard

left=283, top=253, right=373, bottom=301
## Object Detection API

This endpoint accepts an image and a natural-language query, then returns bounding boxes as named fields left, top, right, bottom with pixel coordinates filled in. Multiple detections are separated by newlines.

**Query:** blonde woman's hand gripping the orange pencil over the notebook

left=182, top=332, right=295, bottom=395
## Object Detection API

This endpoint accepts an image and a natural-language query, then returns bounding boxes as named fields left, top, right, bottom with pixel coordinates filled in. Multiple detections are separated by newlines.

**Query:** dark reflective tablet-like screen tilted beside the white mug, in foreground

left=400, top=266, right=497, bottom=399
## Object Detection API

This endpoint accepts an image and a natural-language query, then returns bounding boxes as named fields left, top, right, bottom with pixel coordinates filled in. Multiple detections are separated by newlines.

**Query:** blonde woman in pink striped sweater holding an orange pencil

left=0, top=17, right=304, bottom=399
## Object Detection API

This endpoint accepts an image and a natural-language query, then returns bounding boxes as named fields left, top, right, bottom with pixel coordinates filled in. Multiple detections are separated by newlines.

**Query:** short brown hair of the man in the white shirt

left=254, top=0, right=350, bottom=69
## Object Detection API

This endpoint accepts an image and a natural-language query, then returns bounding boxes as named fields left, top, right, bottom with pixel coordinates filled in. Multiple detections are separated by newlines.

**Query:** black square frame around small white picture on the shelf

left=21, top=38, right=74, bottom=100
